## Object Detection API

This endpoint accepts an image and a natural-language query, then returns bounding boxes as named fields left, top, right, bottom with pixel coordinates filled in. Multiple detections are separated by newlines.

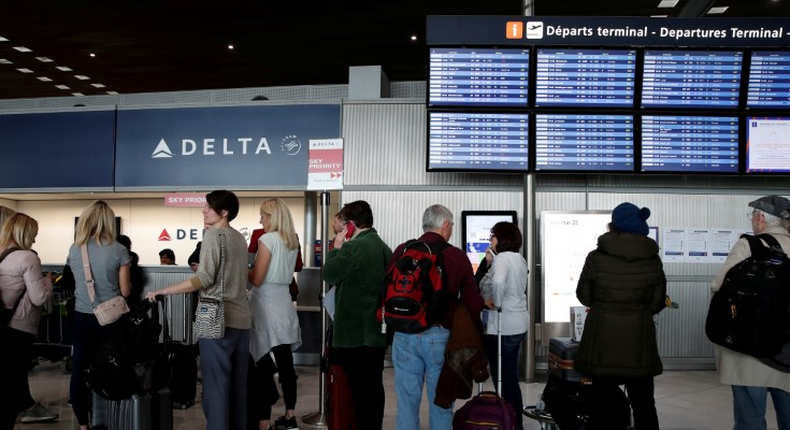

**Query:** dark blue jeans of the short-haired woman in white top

left=483, top=333, right=526, bottom=429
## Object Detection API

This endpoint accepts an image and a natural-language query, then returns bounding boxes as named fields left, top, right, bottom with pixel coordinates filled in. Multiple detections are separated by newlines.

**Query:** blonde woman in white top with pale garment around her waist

left=248, top=199, right=302, bottom=430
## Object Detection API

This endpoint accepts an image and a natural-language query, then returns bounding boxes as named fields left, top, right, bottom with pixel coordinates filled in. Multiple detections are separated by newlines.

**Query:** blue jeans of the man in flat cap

left=732, top=385, right=790, bottom=430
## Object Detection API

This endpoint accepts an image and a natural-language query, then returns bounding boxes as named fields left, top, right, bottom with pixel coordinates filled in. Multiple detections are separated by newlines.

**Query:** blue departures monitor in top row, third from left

left=642, top=50, right=743, bottom=109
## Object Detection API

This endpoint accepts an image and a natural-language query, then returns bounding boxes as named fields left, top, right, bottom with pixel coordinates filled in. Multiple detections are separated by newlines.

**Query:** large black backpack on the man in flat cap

left=705, top=234, right=790, bottom=358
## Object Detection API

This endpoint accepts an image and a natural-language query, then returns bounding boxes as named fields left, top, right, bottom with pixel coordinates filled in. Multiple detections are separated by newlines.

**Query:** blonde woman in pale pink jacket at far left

left=0, top=212, right=52, bottom=430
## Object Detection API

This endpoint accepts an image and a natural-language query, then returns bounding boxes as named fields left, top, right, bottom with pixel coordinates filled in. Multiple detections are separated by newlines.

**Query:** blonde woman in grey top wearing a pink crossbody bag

left=67, top=200, right=132, bottom=429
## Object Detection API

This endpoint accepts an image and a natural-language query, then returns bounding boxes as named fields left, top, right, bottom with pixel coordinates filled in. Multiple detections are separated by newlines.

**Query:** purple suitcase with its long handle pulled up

left=453, top=308, right=520, bottom=430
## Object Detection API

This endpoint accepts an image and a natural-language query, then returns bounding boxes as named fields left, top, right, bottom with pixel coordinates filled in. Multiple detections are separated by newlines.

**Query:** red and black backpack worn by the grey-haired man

left=377, top=239, right=450, bottom=333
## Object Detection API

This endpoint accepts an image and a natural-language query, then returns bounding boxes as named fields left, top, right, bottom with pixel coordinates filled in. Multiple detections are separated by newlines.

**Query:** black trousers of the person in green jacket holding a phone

left=334, top=346, right=387, bottom=430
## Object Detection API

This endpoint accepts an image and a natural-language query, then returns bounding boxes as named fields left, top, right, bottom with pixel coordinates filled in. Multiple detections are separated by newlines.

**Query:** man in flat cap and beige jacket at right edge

left=711, top=196, right=790, bottom=430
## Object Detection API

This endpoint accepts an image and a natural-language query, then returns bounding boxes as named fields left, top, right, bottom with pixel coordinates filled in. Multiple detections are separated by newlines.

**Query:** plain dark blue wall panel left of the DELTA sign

left=0, top=110, right=115, bottom=191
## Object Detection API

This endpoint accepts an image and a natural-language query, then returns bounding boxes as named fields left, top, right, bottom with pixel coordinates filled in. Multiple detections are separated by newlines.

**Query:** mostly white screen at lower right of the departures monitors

left=746, top=117, right=790, bottom=173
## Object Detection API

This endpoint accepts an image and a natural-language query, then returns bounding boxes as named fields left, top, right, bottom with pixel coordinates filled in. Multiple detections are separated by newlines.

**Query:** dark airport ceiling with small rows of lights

left=0, top=0, right=790, bottom=99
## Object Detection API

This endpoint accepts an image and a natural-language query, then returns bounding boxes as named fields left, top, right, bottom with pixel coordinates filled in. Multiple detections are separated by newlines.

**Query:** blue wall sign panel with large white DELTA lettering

left=115, top=104, right=340, bottom=189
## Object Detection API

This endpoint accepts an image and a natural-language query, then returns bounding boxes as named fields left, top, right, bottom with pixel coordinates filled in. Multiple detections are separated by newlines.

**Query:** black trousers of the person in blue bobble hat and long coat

left=590, top=376, right=658, bottom=430
